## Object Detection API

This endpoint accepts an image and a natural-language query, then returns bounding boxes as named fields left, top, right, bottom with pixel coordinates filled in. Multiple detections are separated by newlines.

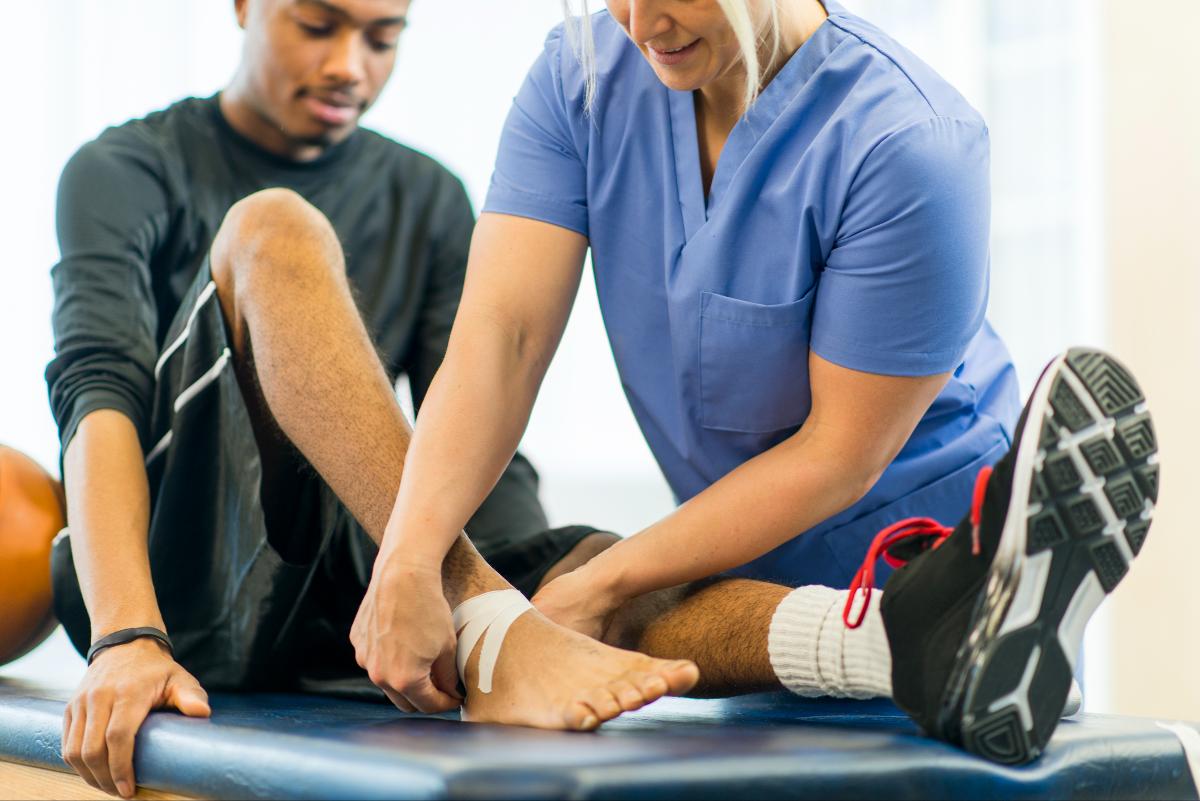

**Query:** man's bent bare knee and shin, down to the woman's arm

left=211, top=189, right=412, bottom=542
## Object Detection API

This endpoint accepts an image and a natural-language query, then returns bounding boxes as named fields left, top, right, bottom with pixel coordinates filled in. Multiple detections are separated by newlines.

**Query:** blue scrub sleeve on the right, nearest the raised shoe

left=811, top=116, right=990, bottom=375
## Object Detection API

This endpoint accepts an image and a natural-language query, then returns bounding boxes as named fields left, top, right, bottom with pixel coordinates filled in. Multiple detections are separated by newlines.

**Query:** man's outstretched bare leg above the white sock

left=542, top=534, right=792, bottom=698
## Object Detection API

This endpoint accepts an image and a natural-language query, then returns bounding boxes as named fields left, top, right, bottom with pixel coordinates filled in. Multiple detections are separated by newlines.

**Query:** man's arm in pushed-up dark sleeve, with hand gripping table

left=47, top=132, right=209, bottom=797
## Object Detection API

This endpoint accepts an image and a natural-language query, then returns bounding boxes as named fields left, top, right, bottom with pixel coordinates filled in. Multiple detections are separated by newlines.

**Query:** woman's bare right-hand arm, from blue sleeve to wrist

left=589, top=354, right=949, bottom=601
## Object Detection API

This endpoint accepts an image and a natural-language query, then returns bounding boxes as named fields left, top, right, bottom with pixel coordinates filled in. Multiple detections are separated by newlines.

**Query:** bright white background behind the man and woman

left=0, top=0, right=1105, bottom=709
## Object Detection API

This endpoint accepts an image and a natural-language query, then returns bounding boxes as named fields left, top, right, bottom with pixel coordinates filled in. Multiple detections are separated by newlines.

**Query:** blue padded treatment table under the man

left=0, top=679, right=1200, bottom=799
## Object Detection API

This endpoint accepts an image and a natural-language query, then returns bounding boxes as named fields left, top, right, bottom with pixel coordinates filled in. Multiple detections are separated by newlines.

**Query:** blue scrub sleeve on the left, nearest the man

left=484, top=28, right=588, bottom=236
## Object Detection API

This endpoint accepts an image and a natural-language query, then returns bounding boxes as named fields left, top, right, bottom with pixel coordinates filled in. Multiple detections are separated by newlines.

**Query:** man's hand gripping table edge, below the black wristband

left=62, top=638, right=211, bottom=799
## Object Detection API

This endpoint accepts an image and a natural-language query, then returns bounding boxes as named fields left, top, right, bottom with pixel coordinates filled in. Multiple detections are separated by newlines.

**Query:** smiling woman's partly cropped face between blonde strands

left=607, top=0, right=761, bottom=91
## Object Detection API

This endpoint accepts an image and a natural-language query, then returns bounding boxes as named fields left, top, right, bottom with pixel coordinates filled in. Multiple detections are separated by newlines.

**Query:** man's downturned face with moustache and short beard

left=235, top=0, right=409, bottom=145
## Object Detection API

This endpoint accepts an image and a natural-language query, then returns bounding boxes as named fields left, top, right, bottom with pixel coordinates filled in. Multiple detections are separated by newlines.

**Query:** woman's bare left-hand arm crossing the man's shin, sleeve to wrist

left=369, top=213, right=587, bottom=567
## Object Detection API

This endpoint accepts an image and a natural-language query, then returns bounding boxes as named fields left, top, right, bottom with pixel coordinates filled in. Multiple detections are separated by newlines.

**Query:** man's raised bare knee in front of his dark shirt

left=209, top=187, right=344, bottom=302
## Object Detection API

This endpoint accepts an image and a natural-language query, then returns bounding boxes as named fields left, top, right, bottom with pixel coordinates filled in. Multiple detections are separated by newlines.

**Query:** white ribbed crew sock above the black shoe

left=767, top=585, right=892, bottom=698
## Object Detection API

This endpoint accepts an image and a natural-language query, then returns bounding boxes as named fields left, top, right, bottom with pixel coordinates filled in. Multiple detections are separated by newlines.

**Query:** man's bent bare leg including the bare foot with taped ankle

left=211, top=189, right=696, bottom=729
